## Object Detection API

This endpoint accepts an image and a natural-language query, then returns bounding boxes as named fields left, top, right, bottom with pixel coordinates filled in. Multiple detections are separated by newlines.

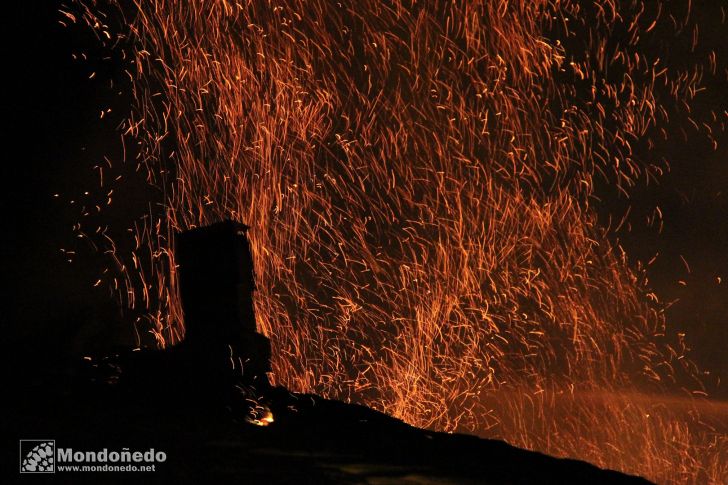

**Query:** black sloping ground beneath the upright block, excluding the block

left=2, top=346, right=649, bottom=485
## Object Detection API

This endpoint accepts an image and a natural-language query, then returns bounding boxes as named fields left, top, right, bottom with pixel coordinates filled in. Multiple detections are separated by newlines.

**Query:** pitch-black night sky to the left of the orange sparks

left=0, top=2, right=150, bottom=382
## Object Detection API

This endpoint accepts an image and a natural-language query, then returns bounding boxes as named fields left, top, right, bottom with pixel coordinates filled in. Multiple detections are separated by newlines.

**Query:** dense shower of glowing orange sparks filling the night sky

left=71, top=0, right=728, bottom=483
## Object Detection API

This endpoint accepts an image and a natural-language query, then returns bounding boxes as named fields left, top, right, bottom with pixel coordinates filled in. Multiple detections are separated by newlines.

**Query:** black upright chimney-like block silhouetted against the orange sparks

left=175, top=221, right=270, bottom=387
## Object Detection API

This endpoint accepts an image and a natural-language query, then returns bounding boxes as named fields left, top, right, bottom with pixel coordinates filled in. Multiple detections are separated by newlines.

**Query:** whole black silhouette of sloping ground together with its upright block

left=8, top=221, right=649, bottom=484
